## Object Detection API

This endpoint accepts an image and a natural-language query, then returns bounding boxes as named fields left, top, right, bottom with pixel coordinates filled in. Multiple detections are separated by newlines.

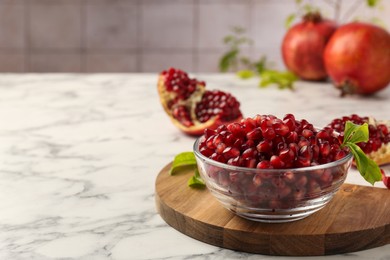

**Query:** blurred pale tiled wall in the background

left=0, top=0, right=390, bottom=72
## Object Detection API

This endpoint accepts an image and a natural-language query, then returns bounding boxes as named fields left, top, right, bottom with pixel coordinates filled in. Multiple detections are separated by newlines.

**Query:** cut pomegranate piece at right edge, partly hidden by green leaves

left=328, top=114, right=390, bottom=165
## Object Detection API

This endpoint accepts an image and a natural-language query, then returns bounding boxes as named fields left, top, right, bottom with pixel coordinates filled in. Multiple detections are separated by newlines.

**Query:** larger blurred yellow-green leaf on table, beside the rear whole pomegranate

left=259, top=70, right=298, bottom=89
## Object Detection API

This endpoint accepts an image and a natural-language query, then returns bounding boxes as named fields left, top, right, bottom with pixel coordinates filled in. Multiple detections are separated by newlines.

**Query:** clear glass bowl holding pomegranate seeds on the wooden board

left=193, top=137, right=353, bottom=223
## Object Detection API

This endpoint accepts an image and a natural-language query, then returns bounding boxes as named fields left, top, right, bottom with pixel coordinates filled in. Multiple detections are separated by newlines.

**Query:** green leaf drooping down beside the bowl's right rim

left=345, top=142, right=382, bottom=185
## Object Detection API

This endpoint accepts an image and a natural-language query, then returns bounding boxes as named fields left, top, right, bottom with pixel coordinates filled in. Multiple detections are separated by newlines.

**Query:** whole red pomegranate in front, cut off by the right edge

left=324, top=22, right=390, bottom=95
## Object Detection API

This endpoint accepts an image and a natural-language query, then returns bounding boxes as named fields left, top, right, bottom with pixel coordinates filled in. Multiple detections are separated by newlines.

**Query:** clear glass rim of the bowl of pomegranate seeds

left=193, top=135, right=353, bottom=173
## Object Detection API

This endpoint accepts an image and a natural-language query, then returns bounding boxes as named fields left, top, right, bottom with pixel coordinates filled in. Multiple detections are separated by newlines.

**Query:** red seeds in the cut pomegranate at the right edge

left=329, top=114, right=390, bottom=154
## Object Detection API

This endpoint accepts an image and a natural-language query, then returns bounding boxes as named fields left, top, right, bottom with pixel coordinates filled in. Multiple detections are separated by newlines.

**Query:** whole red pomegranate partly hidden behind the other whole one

left=282, top=13, right=337, bottom=80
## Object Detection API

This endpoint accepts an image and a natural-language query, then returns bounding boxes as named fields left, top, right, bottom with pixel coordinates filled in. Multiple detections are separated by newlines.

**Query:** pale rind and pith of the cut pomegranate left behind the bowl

left=157, top=74, right=243, bottom=136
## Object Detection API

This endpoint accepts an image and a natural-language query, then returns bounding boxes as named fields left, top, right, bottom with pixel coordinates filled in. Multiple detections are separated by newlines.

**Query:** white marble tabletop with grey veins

left=0, top=74, right=390, bottom=259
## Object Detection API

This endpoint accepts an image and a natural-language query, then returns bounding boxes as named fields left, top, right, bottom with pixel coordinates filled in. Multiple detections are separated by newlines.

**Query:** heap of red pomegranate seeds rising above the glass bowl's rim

left=199, top=114, right=348, bottom=169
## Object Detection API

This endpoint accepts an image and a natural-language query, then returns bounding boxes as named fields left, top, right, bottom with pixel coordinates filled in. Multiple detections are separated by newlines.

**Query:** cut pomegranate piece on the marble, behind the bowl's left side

left=157, top=68, right=242, bottom=136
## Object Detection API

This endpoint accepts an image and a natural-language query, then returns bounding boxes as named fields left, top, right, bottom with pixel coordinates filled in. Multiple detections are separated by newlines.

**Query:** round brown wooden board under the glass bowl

left=155, top=164, right=390, bottom=256
